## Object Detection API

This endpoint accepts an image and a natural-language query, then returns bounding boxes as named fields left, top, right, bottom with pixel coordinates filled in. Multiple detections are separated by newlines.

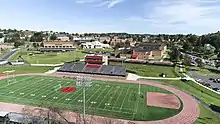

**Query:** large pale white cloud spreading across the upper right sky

left=126, top=0, right=220, bottom=31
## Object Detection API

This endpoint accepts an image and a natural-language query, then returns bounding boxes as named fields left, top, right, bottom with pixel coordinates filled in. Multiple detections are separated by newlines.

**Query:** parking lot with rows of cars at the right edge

left=189, top=71, right=220, bottom=89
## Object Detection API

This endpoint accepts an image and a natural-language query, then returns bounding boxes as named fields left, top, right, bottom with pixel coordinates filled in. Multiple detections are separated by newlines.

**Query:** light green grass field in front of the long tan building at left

left=11, top=51, right=85, bottom=64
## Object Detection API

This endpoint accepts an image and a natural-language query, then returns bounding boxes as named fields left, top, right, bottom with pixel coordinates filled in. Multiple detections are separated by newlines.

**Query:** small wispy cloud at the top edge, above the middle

left=76, top=0, right=125, bottom=8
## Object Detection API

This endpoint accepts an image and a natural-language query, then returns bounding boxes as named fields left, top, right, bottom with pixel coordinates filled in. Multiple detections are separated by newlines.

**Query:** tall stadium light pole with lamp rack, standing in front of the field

left=76, top=76, right=92, bottom=124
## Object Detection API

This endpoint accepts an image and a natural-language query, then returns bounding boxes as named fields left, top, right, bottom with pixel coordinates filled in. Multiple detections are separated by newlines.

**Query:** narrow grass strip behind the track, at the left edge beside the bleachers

left=0, top=66, right=54, bottom=76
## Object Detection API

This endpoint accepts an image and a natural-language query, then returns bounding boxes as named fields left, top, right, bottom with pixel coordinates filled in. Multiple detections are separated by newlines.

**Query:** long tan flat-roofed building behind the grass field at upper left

left=40, top=41, right=76, bottom=52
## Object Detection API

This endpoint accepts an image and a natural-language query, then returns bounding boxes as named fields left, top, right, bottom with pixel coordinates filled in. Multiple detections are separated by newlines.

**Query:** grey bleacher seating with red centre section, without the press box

left=57, top=63, right=127, bottom=77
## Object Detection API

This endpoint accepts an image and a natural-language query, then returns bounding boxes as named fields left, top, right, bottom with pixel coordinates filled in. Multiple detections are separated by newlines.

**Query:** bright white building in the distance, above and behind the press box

left=81, top=41, right=111, bottom=49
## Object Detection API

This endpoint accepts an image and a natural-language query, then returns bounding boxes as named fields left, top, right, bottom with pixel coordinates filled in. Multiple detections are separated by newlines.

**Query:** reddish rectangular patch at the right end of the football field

left=147, top=92, right=180, bottom=109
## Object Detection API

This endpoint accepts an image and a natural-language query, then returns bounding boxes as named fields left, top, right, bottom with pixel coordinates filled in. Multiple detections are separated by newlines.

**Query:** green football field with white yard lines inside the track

left=0, top=76, right=182, bottom=121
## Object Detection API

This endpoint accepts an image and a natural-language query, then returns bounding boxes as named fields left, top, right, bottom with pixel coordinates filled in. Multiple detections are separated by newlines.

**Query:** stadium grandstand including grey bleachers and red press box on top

left=57, top=55, right=127, bottom=77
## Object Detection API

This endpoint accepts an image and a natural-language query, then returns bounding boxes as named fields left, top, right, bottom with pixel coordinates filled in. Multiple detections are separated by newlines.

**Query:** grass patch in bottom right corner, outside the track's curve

left=194, top=104, right=220, bottom=124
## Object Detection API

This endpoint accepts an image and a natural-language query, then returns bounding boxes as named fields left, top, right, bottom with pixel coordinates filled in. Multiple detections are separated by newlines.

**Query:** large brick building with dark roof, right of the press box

left=132, top=43, right=167, bottom=60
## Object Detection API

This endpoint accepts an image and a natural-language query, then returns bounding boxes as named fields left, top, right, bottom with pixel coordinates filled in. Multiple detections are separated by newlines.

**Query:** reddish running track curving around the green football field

left=0, top=74, right=200, bottom=124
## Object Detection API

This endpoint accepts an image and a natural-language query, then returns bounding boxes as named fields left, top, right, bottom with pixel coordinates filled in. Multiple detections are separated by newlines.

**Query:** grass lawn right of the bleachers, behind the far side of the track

left=110, top=62, right=178, bottom=78
